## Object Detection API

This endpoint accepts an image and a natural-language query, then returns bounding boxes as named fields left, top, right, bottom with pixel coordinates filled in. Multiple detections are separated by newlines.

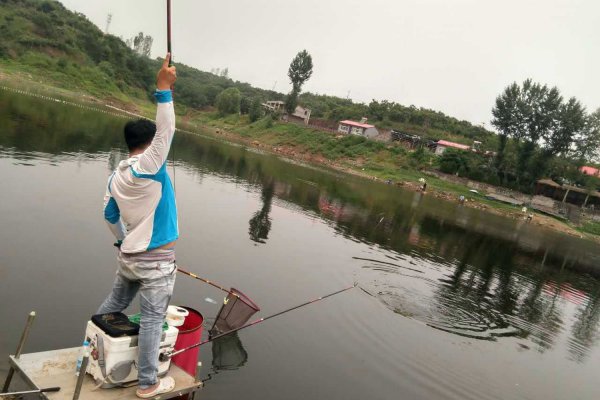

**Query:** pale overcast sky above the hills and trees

left=62, top=0, right=600, bottom=127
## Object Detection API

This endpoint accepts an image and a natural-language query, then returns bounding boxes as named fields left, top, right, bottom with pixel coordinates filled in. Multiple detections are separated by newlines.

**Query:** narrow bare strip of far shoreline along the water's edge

left=0, top=70, right=600, bottom=243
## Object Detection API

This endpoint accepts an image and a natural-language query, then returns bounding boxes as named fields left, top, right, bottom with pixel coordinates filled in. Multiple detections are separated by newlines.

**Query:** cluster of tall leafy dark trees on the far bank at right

left=491, top=79, right=600, bottom=192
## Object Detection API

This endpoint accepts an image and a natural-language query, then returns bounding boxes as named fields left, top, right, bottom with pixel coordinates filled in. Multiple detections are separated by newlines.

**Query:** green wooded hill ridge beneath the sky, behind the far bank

left=0, top=0, right=496, bottom=148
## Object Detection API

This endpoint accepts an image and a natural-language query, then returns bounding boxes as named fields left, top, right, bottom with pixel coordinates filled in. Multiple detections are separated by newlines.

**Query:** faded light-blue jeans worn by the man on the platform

left=97, top=251, right=177, bottom=389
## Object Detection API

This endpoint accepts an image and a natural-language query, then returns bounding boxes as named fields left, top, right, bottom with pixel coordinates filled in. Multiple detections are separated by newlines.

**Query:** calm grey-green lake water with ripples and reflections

left=0, top=91, right=600, bottom=400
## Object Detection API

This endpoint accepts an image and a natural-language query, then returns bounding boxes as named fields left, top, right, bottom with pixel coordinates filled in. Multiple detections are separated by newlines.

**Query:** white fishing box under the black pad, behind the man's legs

left=85, top=321, right=178, bottom=388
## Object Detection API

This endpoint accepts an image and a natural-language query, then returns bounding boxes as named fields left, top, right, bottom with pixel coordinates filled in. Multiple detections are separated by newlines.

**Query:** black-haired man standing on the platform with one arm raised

left=97, top=54, right=179, bottom=398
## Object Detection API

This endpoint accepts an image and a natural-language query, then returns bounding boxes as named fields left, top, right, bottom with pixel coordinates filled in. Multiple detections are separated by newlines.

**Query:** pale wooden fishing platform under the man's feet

left=10, top=347, right=202, bottom=400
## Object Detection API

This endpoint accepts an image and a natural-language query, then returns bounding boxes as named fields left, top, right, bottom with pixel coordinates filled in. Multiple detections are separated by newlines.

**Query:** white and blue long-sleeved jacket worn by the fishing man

left=104, top=90, right=179, bottom=253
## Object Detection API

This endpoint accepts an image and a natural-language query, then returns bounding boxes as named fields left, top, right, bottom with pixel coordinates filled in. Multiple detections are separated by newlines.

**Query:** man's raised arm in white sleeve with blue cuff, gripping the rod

left=136, top=54, right=177, bottom=174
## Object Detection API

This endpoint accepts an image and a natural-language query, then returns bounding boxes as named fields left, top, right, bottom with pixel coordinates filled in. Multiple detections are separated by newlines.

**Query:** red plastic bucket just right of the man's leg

left=172, top=307, right=204, bottom=376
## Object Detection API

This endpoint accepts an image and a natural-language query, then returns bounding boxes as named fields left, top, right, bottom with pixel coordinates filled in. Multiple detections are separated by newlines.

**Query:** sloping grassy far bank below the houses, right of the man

left=186, top=112, right=548, bottom=212
